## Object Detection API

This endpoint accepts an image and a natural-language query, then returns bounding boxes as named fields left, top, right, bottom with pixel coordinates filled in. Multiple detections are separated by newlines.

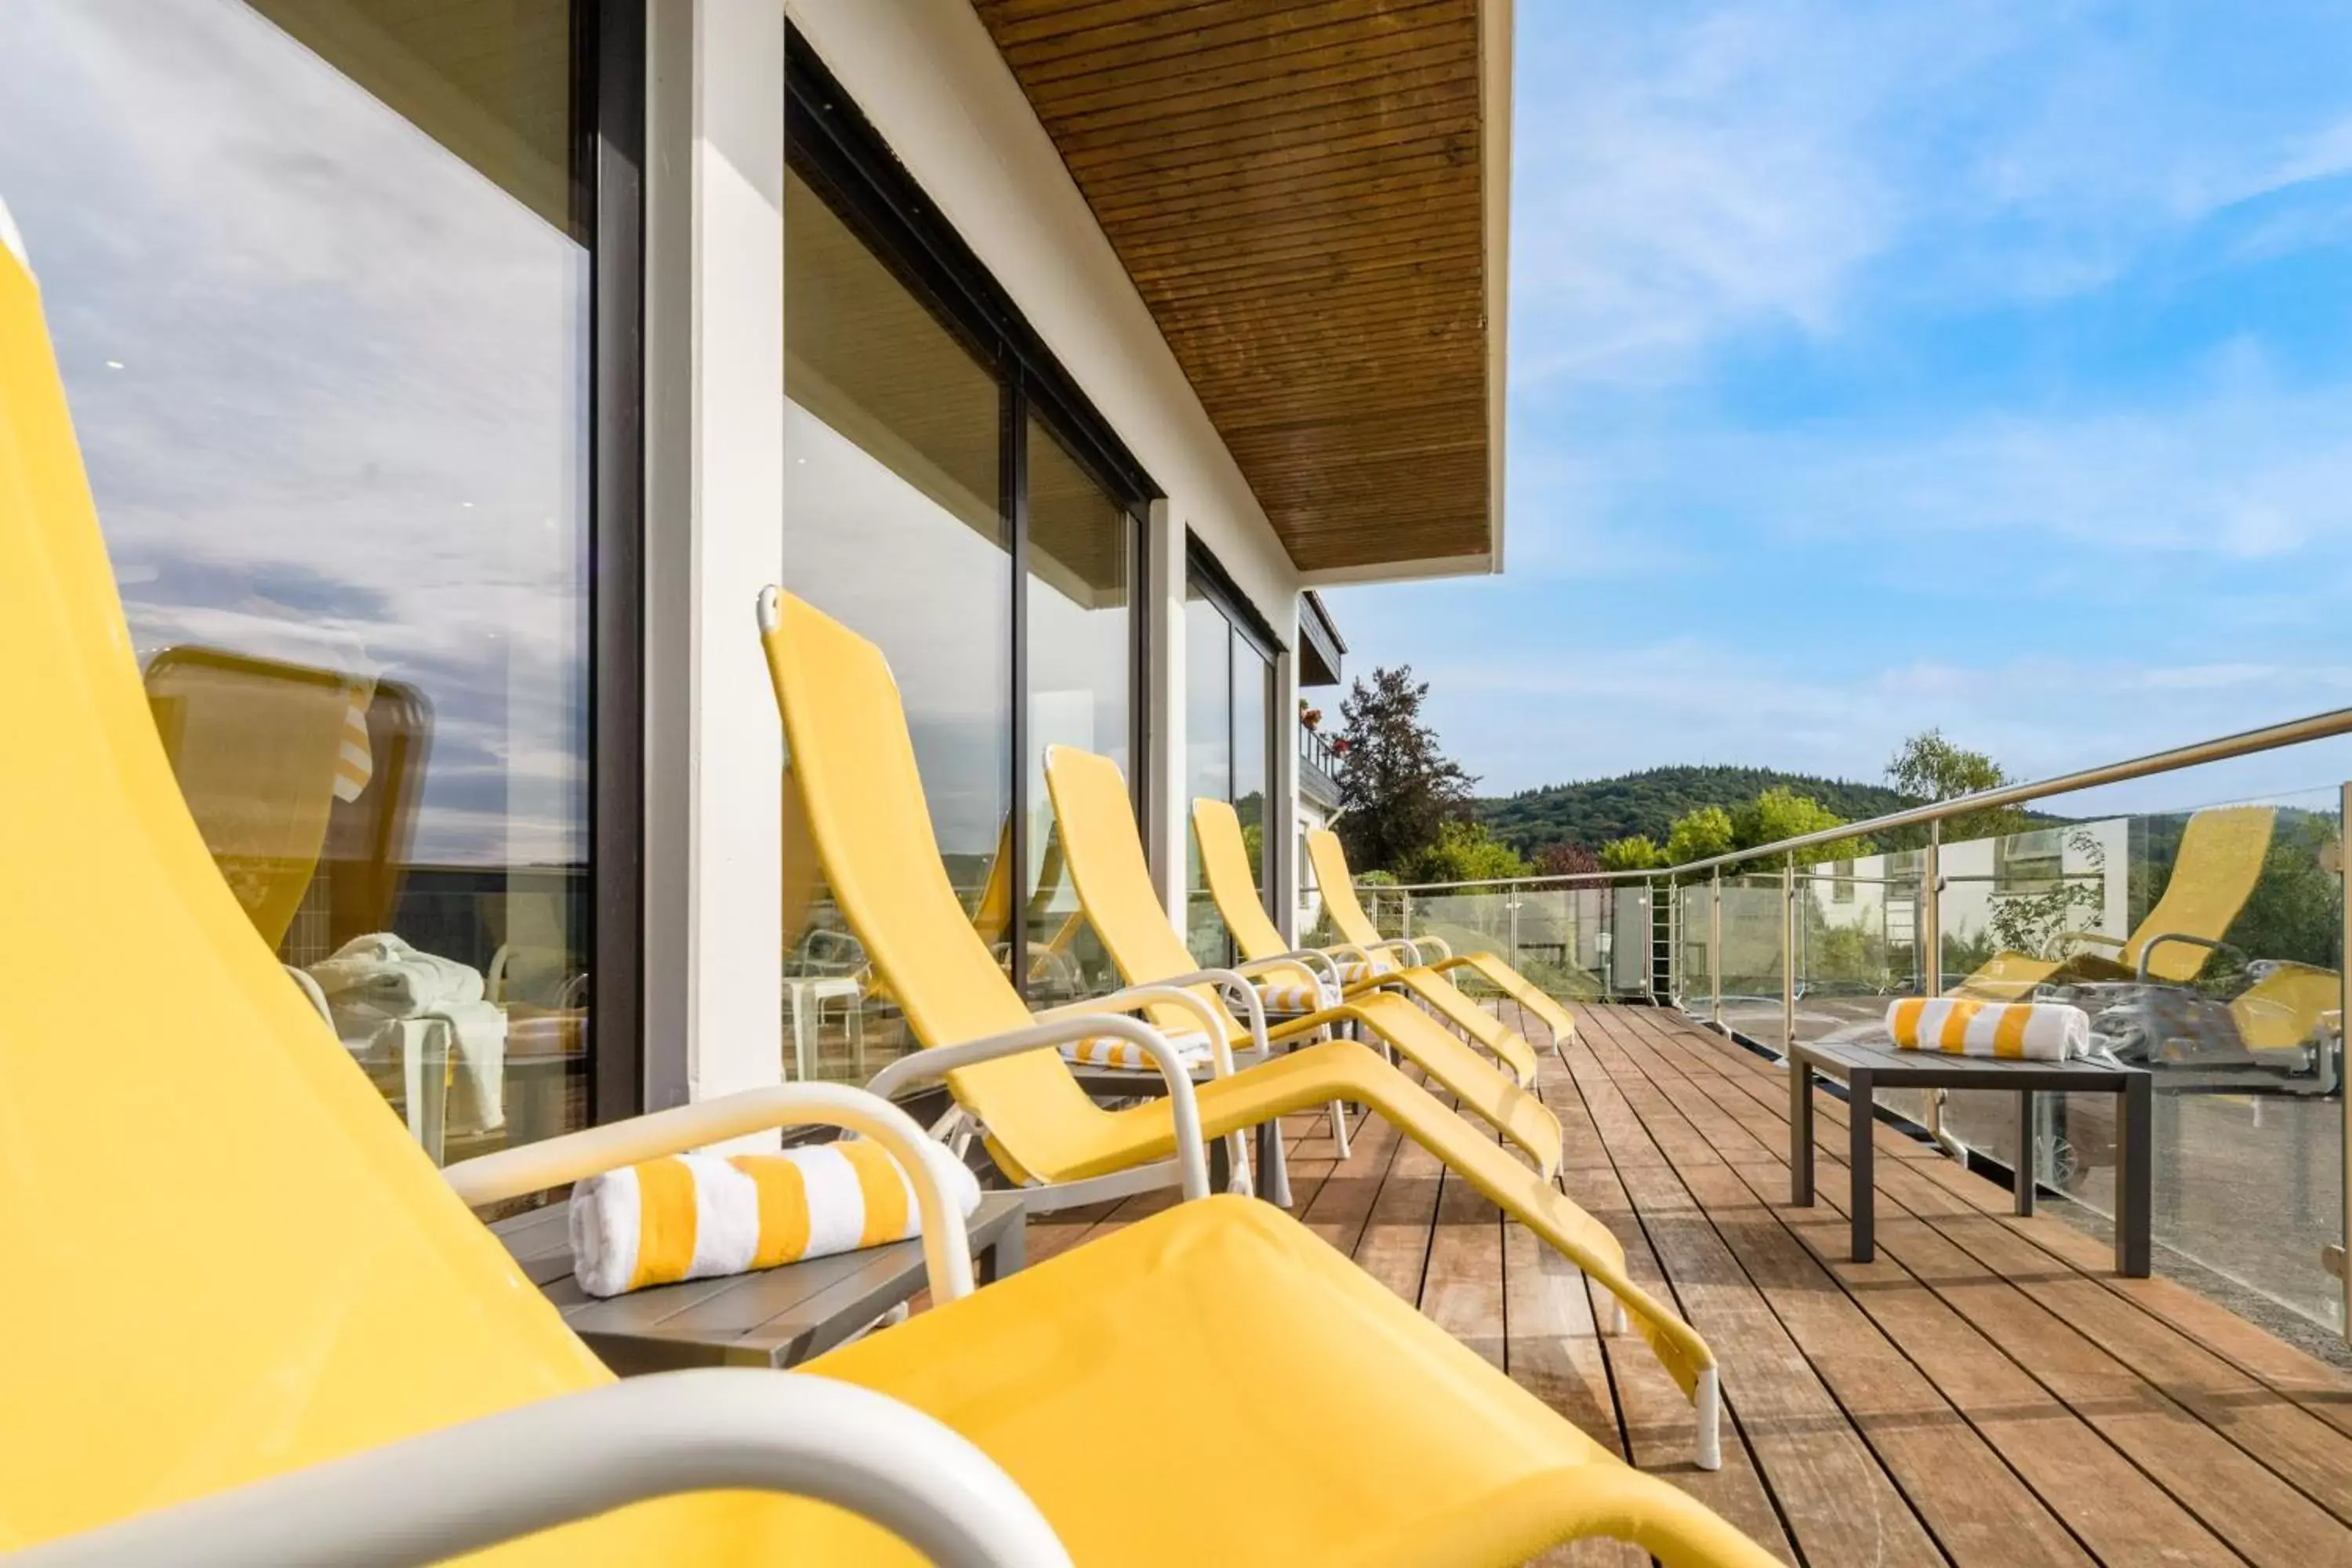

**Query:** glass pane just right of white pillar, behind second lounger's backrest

left=783, top=169, right=1014, bottom=1076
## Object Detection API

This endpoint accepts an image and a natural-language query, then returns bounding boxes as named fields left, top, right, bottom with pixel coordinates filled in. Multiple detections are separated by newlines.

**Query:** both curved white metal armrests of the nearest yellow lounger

left=0, top=1086, right=1077, bottom=1568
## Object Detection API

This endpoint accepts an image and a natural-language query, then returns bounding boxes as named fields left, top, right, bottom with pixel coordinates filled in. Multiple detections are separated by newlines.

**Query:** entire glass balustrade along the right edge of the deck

left=1359, top=779, right=2345, bottom=1326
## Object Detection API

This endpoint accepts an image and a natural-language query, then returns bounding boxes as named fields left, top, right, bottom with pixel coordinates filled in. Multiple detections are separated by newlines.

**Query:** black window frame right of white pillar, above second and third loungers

left=783, top=26, right=1162, bottom=992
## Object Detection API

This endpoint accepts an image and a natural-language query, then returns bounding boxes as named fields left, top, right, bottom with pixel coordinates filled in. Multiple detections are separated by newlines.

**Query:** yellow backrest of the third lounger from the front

left=1044, top=746, right=1240, bottom=1034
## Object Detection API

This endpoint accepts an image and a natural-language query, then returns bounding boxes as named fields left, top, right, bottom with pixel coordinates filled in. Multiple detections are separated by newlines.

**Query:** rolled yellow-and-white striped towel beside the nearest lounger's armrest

left=569, top=1138, right=981, bottom=1295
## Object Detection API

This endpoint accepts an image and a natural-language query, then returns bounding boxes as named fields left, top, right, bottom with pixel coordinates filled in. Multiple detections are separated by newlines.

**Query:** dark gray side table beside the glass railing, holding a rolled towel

left=1788, top=1041, right=2154, bottom=1279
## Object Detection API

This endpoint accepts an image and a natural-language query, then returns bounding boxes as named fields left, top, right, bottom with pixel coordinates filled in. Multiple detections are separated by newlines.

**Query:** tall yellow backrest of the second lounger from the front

left=767, top=595, right=1098, bottom=1171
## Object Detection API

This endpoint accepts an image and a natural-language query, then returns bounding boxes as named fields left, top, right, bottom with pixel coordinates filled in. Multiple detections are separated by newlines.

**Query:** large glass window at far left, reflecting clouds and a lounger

left=0, top=0, right=593, bottom=1159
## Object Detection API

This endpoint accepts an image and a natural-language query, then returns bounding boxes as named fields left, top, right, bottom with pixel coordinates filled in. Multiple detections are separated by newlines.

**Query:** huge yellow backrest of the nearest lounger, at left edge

left=0, top=217, right=873, bottom=1563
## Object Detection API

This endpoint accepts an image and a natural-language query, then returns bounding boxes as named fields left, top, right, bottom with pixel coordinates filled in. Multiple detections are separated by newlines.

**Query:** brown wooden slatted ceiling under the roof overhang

left=974, top=0, right=1501, bottom=572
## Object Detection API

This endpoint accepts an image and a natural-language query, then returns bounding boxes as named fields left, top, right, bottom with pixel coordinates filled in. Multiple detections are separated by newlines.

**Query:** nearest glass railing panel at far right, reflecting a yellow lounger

left=1943, top=789, right=2343, bottom=1326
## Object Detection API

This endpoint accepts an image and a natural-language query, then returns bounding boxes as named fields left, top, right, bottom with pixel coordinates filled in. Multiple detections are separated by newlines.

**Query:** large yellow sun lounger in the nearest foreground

left=0, top=211, right=1771, bottom=1568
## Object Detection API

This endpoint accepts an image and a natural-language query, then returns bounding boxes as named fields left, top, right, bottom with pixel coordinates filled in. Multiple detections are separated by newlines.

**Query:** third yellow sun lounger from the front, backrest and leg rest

left=1044, top=746, right=1559, bottom=1175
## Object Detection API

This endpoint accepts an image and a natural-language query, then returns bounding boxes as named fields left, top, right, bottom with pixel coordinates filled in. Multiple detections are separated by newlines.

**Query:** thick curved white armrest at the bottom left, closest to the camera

left=5, top=1368, right=1070, bottom=1568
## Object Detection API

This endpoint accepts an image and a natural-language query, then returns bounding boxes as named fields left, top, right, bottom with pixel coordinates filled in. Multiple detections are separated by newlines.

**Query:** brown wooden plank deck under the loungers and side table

left=1030, top=1008, right=2352, bottom=1568
